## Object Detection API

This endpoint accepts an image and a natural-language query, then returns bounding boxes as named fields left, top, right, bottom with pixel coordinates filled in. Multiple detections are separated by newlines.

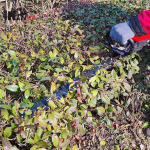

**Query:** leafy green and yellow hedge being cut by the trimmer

left=0, top=1, right=150, bottom=150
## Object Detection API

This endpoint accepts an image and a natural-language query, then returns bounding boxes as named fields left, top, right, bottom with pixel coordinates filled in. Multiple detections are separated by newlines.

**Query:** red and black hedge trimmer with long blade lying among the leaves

left=27, top=31, right=150, bottom=116
